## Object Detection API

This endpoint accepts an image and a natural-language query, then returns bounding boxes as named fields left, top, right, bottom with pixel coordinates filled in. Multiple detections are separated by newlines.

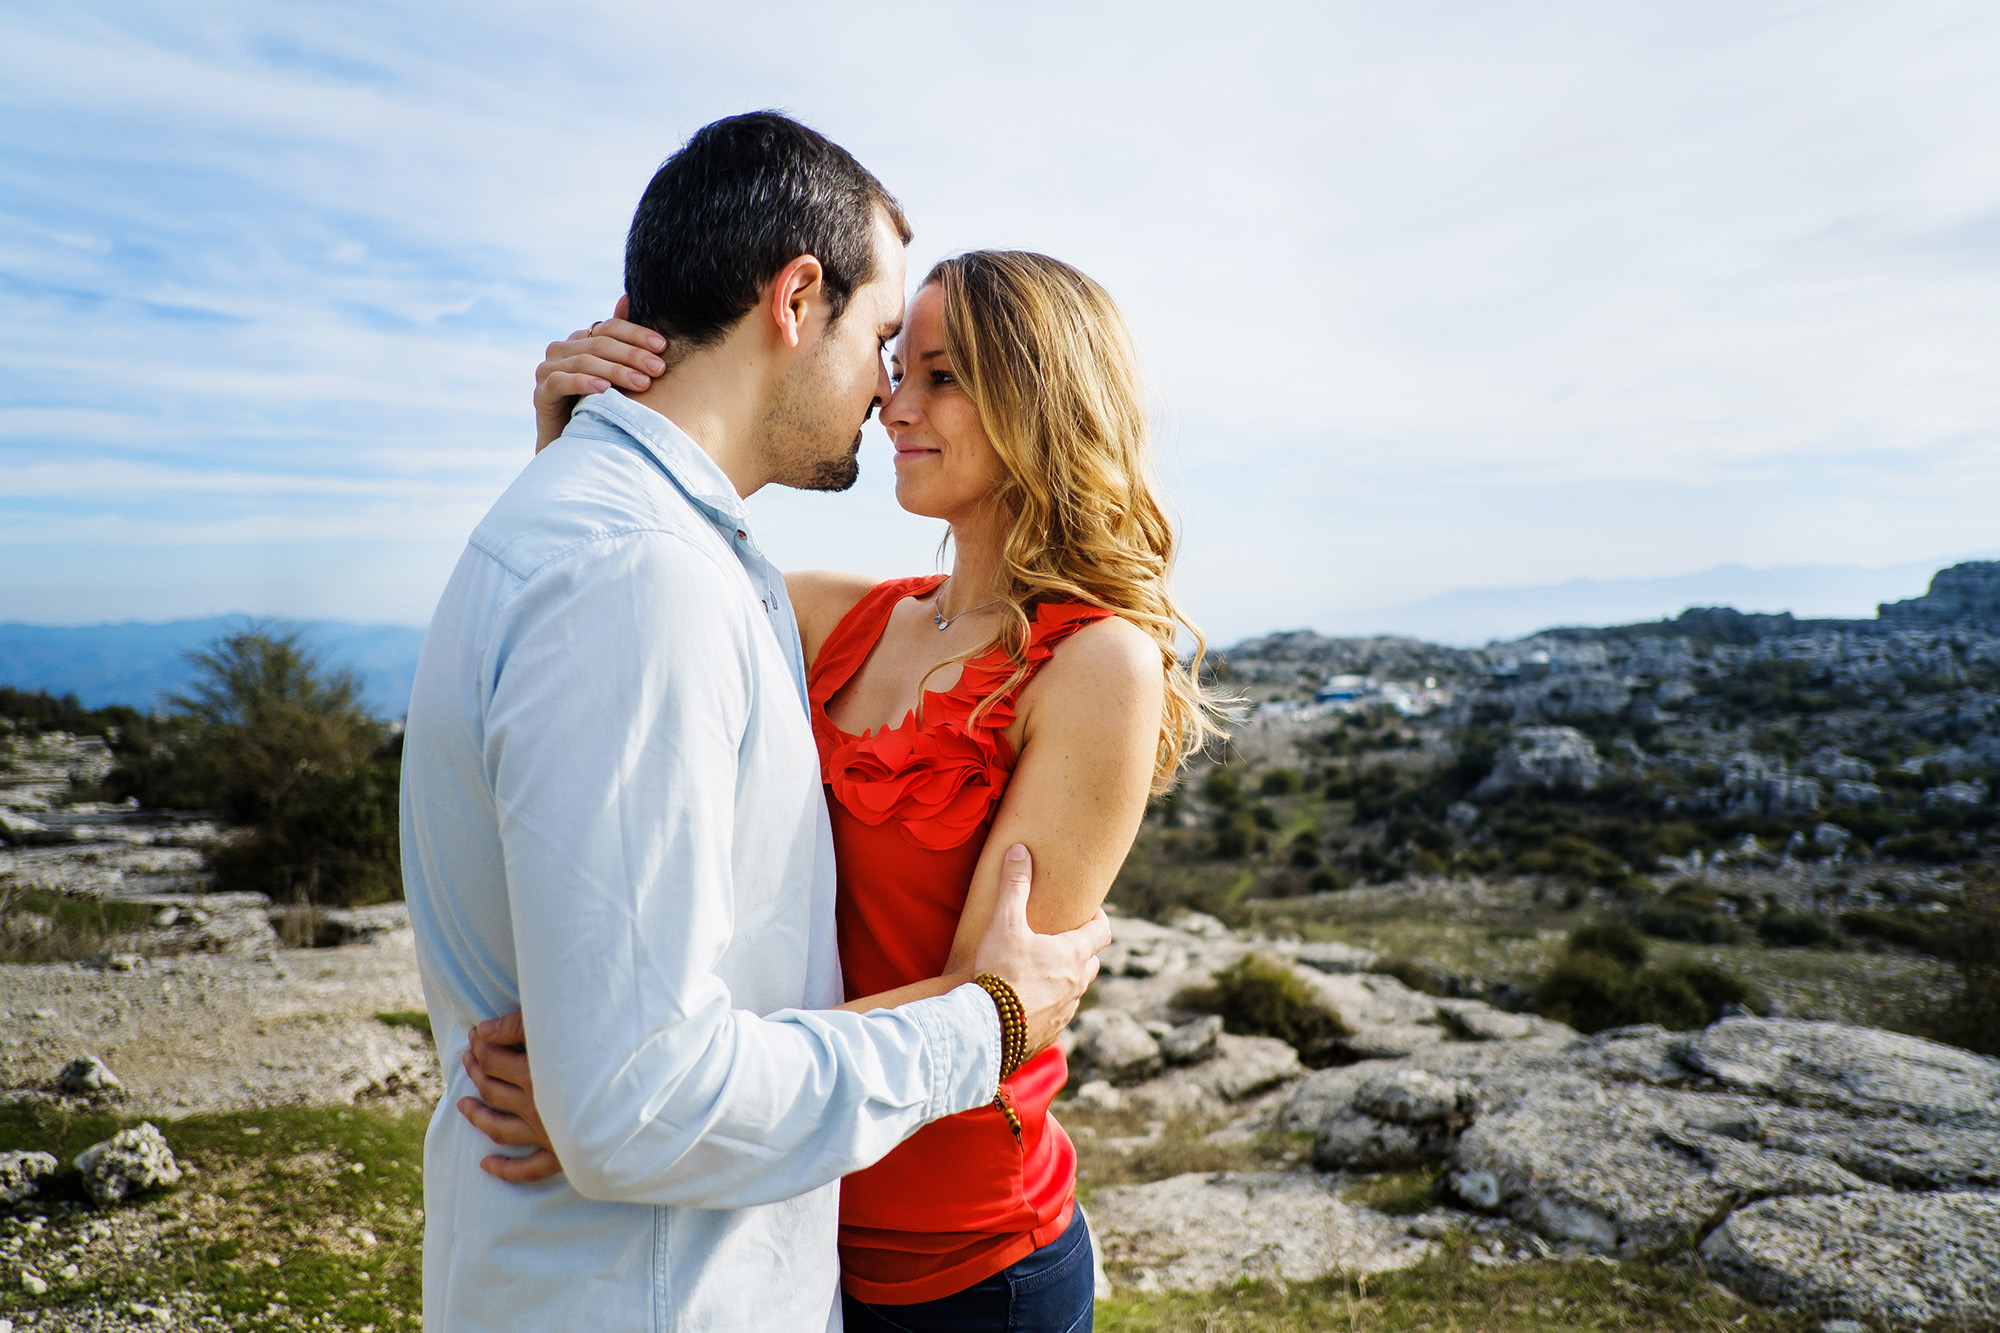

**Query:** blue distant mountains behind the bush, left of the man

left=0, top=616, right=424, bottom=719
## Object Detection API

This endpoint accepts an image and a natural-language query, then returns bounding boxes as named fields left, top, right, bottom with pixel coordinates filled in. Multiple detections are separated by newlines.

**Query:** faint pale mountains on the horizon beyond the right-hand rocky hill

left=1316, top=552, right=2000, bottom=648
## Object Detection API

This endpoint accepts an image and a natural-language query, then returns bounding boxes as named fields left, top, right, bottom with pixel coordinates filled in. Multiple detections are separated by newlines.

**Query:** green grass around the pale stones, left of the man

left=0, top=1105, right=430, bottom=1333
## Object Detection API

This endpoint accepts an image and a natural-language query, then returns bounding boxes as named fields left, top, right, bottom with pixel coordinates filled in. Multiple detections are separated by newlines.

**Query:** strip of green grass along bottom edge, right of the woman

left=1096, top=1237, right=1820, bottom=1333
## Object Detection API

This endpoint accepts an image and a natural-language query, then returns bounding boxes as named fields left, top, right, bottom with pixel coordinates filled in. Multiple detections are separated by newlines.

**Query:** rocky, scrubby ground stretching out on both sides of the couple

left=0, top=566, right=2000, bottom=1333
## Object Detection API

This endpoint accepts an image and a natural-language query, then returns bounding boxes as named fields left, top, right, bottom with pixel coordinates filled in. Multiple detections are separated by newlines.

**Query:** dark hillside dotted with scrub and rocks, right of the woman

left=1190, top=562, right=2000, bottom=881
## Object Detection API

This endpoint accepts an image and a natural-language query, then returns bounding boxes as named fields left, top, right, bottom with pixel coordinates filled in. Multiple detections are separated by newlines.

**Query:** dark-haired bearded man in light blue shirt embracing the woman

left=402, top=112, right=1110, bottom=1333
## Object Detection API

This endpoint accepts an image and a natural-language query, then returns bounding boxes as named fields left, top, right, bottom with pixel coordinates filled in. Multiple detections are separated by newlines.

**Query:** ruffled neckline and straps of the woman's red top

left=810, top=578, right=1112, bottom=851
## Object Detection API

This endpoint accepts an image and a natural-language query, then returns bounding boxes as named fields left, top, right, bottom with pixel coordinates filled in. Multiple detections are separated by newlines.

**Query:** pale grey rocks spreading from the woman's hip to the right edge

left=1072, top=917, right=2000, bottom=1327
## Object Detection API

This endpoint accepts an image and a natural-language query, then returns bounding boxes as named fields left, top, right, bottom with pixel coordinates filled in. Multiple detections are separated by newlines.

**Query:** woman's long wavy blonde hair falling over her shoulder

left=924, top=250, right=1224, bottom=793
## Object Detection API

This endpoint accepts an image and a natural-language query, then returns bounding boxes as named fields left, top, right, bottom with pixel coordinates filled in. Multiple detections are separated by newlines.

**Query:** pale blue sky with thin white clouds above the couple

left=0, top=0, right=2000, bottom=638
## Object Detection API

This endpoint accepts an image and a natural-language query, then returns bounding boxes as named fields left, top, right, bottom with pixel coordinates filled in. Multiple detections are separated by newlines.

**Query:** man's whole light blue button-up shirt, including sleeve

left=402, top=392, right=1000, bottom=1333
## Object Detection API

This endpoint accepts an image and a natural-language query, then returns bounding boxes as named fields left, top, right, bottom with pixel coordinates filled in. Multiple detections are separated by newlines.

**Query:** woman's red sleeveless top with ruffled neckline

left=808, top=576, right=1112, bottom=1305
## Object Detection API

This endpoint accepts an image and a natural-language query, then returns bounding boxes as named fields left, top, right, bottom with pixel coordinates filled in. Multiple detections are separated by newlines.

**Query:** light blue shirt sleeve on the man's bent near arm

left=484, top=532, right=1000, bottom=1209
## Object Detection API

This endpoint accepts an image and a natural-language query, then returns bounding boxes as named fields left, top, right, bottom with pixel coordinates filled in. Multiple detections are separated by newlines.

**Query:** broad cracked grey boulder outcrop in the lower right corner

left=1280, top=1019, right=2000, bottom=1323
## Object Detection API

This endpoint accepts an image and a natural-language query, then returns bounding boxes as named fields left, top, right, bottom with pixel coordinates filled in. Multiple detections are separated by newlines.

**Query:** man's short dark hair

left=626, top=112, right=910, bottom=350
